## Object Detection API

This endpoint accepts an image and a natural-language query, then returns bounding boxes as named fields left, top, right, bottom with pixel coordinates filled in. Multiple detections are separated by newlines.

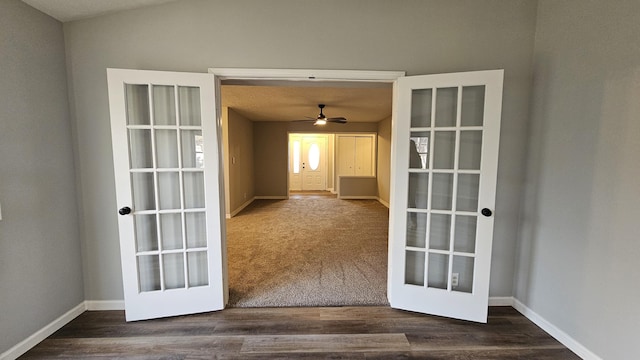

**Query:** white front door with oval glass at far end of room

left=302, top=136, right=327, bottom=190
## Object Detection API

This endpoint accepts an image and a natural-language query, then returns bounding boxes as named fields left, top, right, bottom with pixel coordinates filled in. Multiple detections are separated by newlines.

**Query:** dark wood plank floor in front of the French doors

left=21, top=307, right=579, bottom=360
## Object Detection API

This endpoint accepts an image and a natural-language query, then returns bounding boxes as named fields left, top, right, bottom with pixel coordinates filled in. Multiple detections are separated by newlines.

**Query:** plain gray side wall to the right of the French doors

left=515, top=0, right=640, bottom=359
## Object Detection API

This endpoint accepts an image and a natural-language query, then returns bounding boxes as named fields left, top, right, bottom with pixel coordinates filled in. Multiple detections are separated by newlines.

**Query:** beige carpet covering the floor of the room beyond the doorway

left=227, top=194, right=389, bottom=307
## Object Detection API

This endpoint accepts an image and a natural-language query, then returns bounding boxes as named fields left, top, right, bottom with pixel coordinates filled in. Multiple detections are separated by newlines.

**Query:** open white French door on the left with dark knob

left=107, top=69, right=227, bottom=321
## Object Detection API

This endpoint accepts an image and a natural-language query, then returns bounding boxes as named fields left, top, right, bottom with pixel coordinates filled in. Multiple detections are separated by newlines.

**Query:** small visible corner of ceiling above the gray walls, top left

left=22, top=0, right=175, bottom=22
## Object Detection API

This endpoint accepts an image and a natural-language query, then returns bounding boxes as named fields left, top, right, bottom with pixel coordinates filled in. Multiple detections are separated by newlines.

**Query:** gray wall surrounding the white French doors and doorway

left=64, top=0, right=536, bottom=300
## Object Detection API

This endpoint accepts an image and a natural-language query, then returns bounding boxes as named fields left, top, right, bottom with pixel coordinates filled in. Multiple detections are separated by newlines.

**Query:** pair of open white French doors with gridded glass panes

left=108, top=69, right=503, bottom=322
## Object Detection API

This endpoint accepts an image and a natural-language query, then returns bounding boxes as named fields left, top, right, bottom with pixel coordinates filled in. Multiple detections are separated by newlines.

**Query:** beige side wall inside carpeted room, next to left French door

left=222, top=108, right=255, bottom=215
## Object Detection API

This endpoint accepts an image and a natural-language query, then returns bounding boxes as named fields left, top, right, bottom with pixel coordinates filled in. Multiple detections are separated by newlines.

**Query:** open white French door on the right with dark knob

left=388, top=70, right=503, bottom=322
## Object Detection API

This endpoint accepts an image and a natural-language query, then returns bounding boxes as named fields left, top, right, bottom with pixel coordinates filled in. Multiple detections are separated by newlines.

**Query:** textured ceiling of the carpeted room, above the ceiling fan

left=222, top=84, right=392, bottom=122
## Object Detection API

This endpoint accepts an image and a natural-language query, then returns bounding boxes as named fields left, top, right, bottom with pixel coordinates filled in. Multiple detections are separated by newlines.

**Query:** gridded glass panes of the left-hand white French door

left=125, top=84, right=209, bottom=292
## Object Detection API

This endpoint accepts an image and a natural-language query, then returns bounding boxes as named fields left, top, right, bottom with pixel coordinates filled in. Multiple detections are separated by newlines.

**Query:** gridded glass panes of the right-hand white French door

left=404, top=86, right=485, bottom=293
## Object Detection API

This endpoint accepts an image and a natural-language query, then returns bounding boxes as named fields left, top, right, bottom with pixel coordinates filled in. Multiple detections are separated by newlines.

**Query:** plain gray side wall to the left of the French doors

left=0, top=0, right=84, bottom=354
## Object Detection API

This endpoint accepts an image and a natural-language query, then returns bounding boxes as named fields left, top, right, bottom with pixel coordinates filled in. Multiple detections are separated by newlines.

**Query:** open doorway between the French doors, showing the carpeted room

left=220, top=69, right=402, bottom=307
